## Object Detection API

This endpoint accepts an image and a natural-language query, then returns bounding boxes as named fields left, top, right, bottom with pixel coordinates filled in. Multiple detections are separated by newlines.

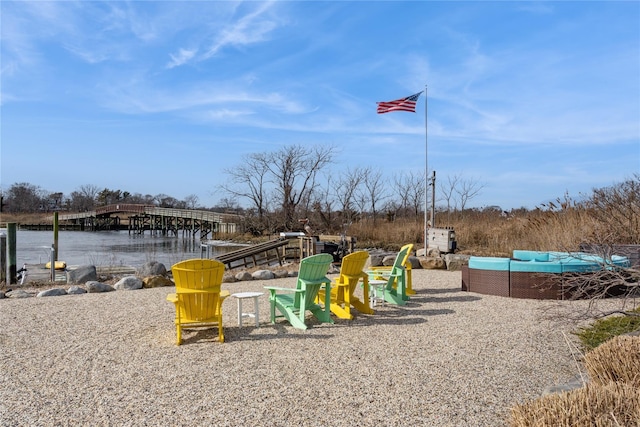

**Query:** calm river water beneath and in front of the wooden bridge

left=0, top=229, right=241, bottom=268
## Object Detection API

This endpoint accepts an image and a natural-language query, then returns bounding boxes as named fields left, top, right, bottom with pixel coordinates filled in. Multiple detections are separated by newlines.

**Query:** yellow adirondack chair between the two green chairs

left=316, top=251, right=373, bottom=319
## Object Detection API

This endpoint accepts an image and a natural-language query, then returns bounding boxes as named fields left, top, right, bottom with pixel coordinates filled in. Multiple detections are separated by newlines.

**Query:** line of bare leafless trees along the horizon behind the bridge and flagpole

left=2, top=145, right=592, bottom=234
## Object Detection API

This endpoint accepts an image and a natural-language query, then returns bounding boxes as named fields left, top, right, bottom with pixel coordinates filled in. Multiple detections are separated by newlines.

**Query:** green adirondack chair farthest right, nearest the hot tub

left=367, top=245, right=410, bottom=305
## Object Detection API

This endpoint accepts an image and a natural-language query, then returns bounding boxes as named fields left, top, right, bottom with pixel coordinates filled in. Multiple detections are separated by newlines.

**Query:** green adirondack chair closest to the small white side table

left=265, top=254, right=333, bottom=329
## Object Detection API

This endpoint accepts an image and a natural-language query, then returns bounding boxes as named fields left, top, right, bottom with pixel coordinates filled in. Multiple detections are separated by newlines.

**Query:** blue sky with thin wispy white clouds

left=0, top=0, right=640, bottom=209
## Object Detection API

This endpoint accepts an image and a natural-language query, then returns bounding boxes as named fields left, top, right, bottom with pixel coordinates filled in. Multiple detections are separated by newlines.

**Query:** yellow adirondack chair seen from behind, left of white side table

left=167, top=259, right=229, bottom=345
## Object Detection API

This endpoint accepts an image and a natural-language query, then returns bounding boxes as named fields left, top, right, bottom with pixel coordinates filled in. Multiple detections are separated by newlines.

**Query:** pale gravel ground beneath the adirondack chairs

left=0, top=270, right=592, bottom=426
